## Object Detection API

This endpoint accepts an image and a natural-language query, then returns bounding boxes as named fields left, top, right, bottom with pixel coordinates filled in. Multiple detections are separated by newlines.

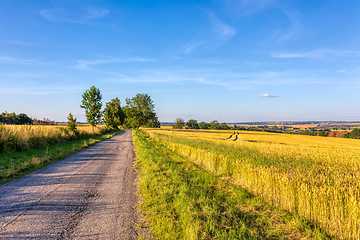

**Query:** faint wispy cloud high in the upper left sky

left=39, top=7, right=109, bottom=24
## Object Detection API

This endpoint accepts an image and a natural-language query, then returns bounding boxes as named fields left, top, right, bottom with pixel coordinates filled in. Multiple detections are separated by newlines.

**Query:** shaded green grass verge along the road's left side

left=0, top=130, right=123, bottom=184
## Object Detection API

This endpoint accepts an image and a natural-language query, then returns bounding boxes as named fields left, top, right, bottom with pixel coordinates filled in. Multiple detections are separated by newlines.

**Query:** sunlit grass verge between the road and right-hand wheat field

left=133, top=131, right=330, bottom=239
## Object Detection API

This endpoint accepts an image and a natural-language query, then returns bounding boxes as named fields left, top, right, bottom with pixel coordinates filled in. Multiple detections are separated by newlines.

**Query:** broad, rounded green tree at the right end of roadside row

left=124, top=93, right=160, bottom=128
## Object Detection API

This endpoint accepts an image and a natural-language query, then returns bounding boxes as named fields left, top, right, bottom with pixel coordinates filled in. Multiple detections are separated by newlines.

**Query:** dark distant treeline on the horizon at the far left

left=0, top=112, right=56, bottom=125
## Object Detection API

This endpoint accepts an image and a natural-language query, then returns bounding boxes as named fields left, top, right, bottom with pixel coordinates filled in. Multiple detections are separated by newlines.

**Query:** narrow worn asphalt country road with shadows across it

left=0, top=130, right=139, bottom=239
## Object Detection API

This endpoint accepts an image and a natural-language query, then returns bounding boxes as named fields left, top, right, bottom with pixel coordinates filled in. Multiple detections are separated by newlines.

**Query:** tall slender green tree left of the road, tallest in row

left=80, top=86, right=102, bottom=132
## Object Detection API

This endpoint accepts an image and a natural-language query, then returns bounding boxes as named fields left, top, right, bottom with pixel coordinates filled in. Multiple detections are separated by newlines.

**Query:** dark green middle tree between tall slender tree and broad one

left=104, top=98, right=125, bottom=129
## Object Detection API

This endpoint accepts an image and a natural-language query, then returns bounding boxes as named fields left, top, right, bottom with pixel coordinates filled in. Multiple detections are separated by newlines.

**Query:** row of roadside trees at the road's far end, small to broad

left=79, top=86, right=160, bottom=130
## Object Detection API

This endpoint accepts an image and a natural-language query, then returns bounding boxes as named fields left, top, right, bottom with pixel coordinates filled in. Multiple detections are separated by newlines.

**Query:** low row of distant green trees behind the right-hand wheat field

left=173, top=118, right=230, bottom=130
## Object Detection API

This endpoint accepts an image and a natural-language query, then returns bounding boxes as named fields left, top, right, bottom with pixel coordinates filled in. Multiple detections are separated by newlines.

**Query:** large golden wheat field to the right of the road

left=145, top=129, right=360, bottom=239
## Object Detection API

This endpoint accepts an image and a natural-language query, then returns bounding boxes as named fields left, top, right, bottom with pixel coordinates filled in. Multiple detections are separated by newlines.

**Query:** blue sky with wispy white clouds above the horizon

left=0, top=0, right=360, bottom=122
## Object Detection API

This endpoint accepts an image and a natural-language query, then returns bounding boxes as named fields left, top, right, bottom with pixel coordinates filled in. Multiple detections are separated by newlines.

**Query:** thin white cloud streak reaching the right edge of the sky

left=271, top=49, right=360, bottom=58
